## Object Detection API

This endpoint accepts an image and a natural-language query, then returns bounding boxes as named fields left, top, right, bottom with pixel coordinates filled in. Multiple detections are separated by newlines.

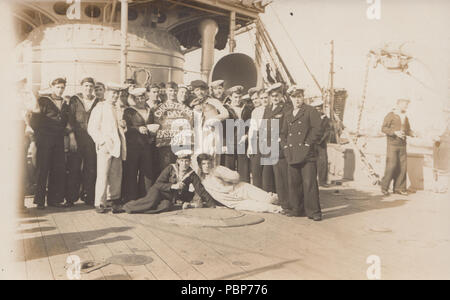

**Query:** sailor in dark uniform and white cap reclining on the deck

left=123, top=150, right=215, bottom=214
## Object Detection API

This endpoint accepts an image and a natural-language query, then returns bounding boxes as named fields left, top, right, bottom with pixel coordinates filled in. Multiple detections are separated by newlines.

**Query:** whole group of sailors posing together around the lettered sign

left=19, top=77, right=330, bottom=221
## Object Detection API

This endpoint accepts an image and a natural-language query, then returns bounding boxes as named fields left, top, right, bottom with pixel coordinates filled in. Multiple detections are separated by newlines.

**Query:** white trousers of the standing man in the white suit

left=95, top=148, right=122, bottom=207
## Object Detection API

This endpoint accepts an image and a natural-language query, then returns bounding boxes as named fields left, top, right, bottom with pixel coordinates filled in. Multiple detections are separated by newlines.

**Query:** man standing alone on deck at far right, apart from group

left=381, top=99, right=416, bottom=196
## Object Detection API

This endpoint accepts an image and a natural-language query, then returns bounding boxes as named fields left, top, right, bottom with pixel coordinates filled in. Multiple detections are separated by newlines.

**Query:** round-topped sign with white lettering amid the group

left=154, top=102, right=194, bottom=147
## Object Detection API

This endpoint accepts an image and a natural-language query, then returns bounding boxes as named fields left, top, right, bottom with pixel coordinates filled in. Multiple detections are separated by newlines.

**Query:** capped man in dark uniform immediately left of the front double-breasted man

left=260, top=83, right=289, bottom=209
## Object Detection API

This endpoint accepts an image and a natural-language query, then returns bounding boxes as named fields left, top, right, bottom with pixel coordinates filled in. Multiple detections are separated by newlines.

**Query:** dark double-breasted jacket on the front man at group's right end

left=281, top=104, right=323, bottom=165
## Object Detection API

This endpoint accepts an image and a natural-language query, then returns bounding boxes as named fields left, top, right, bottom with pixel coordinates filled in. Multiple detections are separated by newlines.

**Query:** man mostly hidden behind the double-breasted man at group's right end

left=311, top=99, right=332, bottom=187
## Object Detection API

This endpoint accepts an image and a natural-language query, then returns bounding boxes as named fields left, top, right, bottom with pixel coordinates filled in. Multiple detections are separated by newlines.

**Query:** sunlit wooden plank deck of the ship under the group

left=10, top=183, right=450, bottom=280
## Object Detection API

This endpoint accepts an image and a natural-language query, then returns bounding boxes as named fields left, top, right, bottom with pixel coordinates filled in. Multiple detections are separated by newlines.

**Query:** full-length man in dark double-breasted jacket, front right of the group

left=281, top=86, right=322, bottom=221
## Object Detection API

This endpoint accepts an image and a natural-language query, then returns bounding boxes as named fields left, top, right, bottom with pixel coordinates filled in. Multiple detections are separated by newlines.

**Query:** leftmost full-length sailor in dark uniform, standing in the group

left=30, top=78, right=69, bottom=209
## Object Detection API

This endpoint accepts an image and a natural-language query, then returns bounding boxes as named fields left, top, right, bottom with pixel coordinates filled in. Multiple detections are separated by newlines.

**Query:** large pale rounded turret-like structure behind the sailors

left=17, top=24, right=184, bottom=94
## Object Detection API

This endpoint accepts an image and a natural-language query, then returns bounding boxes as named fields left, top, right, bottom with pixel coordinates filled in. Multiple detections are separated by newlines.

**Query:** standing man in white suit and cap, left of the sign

left=88, top=84, right=126, bottom=213
